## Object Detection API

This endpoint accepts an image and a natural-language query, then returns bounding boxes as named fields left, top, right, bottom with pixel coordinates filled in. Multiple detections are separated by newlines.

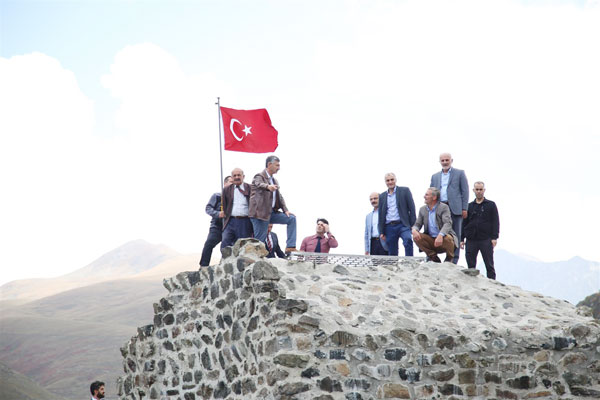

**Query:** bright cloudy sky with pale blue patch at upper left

left=0, top=0, right=600, bottom=284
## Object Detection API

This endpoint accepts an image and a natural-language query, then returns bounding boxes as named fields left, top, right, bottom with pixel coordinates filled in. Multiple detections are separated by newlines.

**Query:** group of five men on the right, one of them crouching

left=365, top=153, right=500, bottom=279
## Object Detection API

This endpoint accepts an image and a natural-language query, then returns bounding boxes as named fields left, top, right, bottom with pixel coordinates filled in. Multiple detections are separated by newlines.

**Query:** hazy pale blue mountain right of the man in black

left=492, top=250, right=600, bottom=304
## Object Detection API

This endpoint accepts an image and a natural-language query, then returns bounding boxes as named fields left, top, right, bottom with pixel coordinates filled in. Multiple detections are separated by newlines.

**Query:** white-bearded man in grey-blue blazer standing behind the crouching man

left=429, top=153, right=469, bottom=264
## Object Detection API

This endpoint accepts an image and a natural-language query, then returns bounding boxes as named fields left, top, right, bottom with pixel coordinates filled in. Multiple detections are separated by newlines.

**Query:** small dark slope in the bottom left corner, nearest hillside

left=0, top=363, right=61, bottom=400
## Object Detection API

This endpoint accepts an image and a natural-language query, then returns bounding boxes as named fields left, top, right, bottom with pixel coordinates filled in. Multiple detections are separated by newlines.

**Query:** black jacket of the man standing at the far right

left=461, top=198, right=500, bottom=240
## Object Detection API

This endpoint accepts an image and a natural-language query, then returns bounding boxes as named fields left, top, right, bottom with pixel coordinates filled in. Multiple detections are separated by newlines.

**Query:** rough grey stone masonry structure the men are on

left=118, top=239, right=600, bottom=400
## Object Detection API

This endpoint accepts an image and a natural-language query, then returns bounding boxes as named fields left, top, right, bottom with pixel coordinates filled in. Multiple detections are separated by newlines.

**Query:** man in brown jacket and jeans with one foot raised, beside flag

left=249, top=156, right=297, bottom=253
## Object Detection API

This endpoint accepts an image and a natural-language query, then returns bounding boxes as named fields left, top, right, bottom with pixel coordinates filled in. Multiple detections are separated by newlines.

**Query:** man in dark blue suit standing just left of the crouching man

left=378, top=172, right=416, bottom=256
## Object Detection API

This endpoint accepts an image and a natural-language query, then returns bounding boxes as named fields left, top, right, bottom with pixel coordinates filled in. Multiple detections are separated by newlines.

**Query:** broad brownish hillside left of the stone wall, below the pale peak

left=0, top=279, right=166, bottom=400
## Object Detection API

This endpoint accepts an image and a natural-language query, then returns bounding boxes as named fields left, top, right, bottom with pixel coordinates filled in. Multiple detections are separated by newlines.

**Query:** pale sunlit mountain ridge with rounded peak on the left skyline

left=0, top=240, right=179, bottom=301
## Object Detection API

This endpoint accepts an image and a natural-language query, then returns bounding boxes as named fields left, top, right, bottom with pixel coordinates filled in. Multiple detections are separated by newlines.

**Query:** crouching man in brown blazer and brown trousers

left=412, top=187, right=458, bottom=262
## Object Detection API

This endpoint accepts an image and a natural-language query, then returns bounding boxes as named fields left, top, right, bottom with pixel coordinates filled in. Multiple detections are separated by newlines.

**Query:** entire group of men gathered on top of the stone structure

left=200, top=153, right=500, bottom=279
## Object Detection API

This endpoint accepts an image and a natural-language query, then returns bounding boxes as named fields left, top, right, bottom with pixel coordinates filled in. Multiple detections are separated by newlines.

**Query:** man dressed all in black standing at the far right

left=460, top=182, right=500, bottom=279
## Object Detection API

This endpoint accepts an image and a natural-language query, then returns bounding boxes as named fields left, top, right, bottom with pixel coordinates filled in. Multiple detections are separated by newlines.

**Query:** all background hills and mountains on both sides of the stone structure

left=0, top=240, right=600, bottom=400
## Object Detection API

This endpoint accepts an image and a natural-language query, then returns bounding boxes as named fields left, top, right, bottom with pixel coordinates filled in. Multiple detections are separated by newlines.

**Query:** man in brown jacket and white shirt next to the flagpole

left=221, top=168, right=252, bottom=248
